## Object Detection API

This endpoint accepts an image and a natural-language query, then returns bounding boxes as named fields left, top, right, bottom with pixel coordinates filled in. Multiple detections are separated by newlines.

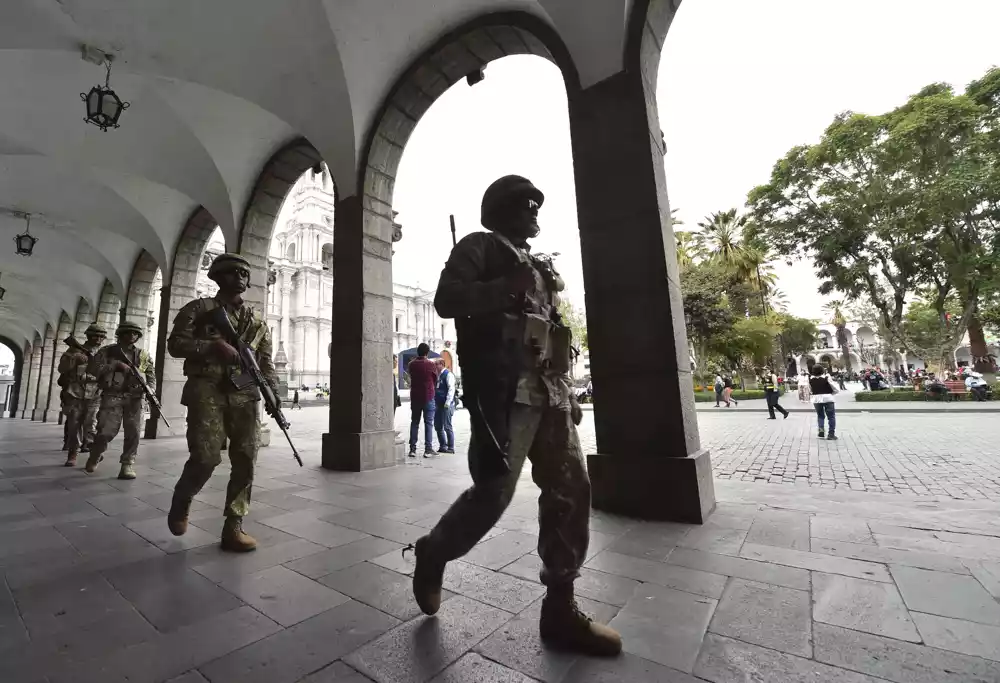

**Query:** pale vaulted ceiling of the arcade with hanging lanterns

left=0, top=0, right=631, bottom=350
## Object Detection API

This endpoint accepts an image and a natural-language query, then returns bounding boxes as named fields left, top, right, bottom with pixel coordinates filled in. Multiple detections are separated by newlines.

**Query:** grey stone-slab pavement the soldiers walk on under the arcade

left=0, top=411, right=1000, bottom=683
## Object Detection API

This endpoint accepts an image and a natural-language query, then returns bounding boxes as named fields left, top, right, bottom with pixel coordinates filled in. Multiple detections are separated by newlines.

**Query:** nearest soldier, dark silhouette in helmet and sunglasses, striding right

left=404, top=176, right=621, bottom=656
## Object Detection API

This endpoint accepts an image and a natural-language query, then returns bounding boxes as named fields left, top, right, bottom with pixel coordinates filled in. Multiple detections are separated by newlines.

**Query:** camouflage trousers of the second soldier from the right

left=174, top=380, right=260, bottom=517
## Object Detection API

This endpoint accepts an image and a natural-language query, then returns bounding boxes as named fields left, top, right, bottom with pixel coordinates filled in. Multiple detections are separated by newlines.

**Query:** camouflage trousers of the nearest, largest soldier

left=428, top=404, right=590, bottom=586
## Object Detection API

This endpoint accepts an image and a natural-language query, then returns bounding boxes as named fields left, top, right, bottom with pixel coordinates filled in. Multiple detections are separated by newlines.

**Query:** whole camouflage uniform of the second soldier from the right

left=167, top=272, right=278, bottom=518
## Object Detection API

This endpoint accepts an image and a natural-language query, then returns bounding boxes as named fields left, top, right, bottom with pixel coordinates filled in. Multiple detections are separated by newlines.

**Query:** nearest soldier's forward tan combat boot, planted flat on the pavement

left=539, top=586, right=622, bottom=657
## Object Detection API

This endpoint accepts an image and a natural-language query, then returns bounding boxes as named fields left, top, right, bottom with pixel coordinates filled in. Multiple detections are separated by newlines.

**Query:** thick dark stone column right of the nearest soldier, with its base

left=568, top=72, right=715, bottom=523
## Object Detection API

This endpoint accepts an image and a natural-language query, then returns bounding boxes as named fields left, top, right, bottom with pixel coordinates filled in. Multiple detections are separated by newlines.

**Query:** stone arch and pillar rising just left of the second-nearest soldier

left=145, top=207, right=218, bottom=439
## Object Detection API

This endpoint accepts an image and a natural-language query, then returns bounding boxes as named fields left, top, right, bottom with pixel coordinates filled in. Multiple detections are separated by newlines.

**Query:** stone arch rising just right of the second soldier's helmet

left=237, top=138, right=323, bottom=311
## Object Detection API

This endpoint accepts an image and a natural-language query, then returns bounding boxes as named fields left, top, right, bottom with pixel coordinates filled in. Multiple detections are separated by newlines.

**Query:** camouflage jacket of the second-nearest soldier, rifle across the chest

left=167, top=298, right=278, bottom=405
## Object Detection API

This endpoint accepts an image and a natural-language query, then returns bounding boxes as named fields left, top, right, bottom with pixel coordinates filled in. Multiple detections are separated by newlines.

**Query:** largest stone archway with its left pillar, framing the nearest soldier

left=323, top=12, right=579, bottom=471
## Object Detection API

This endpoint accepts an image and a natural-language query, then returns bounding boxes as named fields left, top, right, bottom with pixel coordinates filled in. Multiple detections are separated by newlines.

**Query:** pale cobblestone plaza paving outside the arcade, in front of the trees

left=396, top=409, right=1000, bottom=501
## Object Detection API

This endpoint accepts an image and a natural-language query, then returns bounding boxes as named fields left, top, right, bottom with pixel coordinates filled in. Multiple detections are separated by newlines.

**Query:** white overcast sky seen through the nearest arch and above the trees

left=393, top=0, right=1000, bottom=318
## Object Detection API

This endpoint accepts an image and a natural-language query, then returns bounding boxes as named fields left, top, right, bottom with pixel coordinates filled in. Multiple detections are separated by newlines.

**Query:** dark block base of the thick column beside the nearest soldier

left=587, top=450, right=715, bottom=524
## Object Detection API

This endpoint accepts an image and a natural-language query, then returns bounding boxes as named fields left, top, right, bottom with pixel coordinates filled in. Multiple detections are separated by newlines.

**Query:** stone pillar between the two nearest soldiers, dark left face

left=323, top=196, right=396, bottom=472
